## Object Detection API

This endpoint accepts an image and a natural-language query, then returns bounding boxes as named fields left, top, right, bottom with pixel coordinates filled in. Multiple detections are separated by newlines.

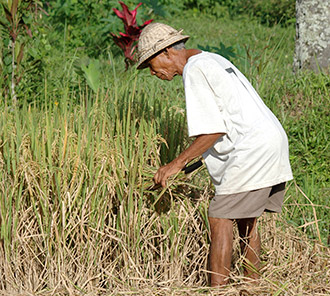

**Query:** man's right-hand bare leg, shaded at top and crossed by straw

left=237, top=218, right=261, bottom=279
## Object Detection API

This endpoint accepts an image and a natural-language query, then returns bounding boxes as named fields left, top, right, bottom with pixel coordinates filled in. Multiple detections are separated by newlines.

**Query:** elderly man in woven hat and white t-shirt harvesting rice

left=138, top=23, right=292, bottom=286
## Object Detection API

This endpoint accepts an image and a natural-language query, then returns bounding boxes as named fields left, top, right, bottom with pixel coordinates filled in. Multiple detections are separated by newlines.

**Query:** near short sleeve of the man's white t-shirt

left=183, top=58, right=232, bottom=137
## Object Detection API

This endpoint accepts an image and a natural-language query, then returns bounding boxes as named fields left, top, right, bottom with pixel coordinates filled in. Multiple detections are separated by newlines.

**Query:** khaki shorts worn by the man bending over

left=209, top=182, right=285, bottom=219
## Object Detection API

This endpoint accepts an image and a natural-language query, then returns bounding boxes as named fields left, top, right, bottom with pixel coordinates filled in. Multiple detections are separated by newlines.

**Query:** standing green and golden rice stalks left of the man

left=0, top=66, right=206, bottom=291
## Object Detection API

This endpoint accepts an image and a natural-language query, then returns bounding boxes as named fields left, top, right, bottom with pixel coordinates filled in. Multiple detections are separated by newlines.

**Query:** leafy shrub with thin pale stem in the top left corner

left=0, top=0, right=50, bottom=103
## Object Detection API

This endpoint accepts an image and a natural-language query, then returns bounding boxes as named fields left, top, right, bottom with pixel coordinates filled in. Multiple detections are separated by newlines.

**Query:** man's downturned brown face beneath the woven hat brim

left=148, top=51, right=178, bottom=80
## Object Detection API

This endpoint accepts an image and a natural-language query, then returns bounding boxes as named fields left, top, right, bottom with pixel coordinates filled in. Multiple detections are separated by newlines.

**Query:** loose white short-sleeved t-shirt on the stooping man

left=182, top=52, right=292, bottom=195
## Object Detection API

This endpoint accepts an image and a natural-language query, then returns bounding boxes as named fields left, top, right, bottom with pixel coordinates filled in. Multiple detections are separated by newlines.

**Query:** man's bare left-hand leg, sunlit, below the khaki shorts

left=209, top=217, right=233, bottom=287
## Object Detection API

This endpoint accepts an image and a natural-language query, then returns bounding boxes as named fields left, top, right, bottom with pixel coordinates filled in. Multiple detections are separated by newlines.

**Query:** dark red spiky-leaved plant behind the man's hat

left=111, top=1, right=153, bottom=70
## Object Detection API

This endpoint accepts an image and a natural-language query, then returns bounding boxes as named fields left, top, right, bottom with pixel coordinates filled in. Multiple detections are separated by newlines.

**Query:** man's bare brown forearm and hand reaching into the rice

left=154, top=133, right=225, bottom=187
